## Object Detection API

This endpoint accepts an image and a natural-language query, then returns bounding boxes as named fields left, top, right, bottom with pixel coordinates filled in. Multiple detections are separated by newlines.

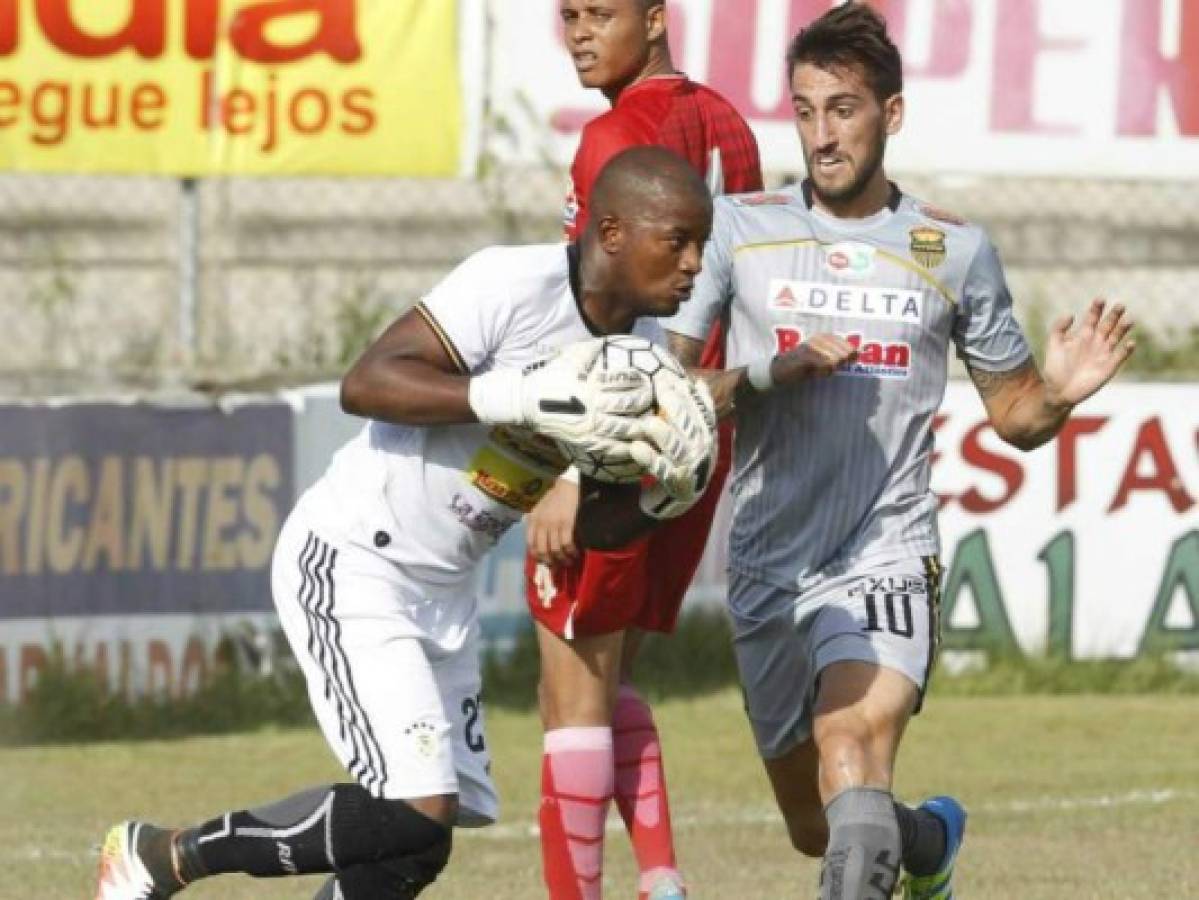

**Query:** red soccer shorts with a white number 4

left=525, top=422, right=733, bottom=640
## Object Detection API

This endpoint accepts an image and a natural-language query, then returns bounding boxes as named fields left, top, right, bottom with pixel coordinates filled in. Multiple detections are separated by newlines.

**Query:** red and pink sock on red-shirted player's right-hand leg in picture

left=611, top=684, right=682, bottom=896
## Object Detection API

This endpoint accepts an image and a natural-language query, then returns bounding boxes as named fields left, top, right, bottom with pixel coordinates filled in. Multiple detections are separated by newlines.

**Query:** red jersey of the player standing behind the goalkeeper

left=565, top=74, right=761, bottom=369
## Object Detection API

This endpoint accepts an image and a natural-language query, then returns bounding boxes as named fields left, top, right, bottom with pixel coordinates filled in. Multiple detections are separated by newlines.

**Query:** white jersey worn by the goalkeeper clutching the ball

left=301, top=244, right=663, bottom=616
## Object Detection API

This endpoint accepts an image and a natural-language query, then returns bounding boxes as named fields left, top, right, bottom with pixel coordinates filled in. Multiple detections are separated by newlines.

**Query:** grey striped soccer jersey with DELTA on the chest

left=665, top=187, right=1029, bottom=587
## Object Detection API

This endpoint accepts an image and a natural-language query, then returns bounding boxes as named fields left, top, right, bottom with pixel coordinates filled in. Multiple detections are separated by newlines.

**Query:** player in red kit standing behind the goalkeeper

left=526, top=0, right=761, bottom=900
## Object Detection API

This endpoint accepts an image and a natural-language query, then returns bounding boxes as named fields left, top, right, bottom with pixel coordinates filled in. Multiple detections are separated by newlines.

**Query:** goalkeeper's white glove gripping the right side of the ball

left=631, top=379, right=718, bottom=519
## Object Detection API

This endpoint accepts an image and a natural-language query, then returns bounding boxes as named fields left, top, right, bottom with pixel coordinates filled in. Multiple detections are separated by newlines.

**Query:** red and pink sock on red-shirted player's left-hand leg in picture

left=538, top=727, right=613, bottom=900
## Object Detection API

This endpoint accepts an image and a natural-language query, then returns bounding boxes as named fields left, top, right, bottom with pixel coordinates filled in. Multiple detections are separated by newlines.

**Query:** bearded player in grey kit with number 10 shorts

left=667, top=4, right=1132, bottom=900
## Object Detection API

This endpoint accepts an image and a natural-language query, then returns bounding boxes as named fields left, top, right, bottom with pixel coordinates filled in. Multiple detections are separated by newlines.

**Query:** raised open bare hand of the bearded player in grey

left=1042, top=300, right=1135, bottom=406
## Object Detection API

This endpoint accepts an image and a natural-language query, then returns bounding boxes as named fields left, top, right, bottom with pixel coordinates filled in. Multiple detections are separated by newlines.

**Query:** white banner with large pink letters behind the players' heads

left=490, top=0, right=1199, bottom=179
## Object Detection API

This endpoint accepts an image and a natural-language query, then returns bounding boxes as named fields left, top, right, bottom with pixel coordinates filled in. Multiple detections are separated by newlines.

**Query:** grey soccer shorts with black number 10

left=729, top=557, right=941, bottom=760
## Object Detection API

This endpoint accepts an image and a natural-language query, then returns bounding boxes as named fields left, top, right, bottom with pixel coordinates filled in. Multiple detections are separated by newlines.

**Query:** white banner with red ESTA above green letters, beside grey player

left=933, top=382, right=1199, bottom=658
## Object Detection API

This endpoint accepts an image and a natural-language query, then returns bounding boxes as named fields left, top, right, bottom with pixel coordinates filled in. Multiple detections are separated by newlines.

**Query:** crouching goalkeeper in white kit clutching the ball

left=97, top=147, right=715, bottom=900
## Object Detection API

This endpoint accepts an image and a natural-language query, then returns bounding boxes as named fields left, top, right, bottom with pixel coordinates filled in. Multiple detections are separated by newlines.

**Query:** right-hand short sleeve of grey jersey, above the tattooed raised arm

left=953, top=236, right=1031, bottom=372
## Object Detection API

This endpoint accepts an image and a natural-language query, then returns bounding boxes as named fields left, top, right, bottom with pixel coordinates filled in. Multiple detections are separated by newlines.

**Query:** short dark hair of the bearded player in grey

left=787, top=0, right=903, bottom=101
